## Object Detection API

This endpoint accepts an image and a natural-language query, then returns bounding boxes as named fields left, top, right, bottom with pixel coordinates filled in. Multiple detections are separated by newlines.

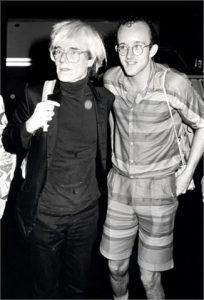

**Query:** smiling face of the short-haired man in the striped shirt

left=117, top=21, right=158, bottom=76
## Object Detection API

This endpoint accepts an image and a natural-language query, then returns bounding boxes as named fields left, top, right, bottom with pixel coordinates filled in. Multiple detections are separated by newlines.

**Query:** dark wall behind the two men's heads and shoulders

left=0, top=1, right=203, bottom=113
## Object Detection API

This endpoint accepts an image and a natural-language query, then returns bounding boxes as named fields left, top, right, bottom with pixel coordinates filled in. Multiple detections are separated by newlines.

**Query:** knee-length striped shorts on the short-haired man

left=100, top=169, right=178, bottom=271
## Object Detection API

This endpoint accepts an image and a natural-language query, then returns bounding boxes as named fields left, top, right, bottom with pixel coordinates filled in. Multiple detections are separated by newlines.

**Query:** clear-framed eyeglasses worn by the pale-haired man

left=51, top=48, right=87, bottom=63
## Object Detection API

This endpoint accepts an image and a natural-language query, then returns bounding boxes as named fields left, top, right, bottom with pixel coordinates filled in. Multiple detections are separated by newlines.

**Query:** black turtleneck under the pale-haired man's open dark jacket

left=40, top=78, right=99, bottom=214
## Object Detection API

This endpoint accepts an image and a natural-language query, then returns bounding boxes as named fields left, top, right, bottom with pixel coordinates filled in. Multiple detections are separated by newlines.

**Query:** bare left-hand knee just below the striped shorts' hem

left=108, top=258, right=129, bottom=277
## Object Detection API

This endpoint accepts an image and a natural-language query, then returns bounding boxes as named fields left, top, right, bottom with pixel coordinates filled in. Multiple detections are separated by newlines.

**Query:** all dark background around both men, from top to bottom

left=0, top=1, right=203, bottom=299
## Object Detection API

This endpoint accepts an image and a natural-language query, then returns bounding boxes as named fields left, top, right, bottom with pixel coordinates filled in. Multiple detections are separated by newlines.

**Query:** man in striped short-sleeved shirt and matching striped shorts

left=100, top=18, right=204, bottom=300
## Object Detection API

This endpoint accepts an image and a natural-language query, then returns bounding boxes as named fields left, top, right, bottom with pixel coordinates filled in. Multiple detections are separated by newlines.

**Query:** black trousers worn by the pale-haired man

left=30, top=206, right=98, bottom=299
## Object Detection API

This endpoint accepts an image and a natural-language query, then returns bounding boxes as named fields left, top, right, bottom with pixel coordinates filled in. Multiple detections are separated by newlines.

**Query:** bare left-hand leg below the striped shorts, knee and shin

left=108, top=258, right=129, bottom=299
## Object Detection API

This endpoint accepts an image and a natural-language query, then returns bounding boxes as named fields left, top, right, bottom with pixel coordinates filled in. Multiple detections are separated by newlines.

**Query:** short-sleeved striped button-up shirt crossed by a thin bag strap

left=104, top=62, right=204, bottom=178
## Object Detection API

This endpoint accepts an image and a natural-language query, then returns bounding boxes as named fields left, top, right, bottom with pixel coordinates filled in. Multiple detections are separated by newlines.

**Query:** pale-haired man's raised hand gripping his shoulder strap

left=26, top=100, right=60, bottom=134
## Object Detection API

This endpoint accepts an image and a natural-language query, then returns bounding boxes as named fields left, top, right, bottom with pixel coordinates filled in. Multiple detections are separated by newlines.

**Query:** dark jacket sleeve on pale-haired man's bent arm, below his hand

left=2, top=85, right=41, bottom=154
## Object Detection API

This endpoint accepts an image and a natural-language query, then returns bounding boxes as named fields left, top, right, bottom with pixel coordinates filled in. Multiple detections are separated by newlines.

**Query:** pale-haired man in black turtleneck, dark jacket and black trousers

left=3, top=20, right=114, bottom=299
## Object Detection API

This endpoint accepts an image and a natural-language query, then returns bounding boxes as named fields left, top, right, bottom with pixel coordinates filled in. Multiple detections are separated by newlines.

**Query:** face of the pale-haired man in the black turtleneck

left=51, top=38, right=94, bottom=82
